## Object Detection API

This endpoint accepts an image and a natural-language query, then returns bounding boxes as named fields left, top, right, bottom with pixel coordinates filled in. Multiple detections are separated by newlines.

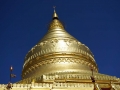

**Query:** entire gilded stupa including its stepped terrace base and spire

left=0, top=10, right=120, bottom=90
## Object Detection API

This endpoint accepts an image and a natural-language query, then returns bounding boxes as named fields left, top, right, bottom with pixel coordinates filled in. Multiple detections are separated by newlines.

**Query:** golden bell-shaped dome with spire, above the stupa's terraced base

left=22, top=11, right=98, bottom=79
